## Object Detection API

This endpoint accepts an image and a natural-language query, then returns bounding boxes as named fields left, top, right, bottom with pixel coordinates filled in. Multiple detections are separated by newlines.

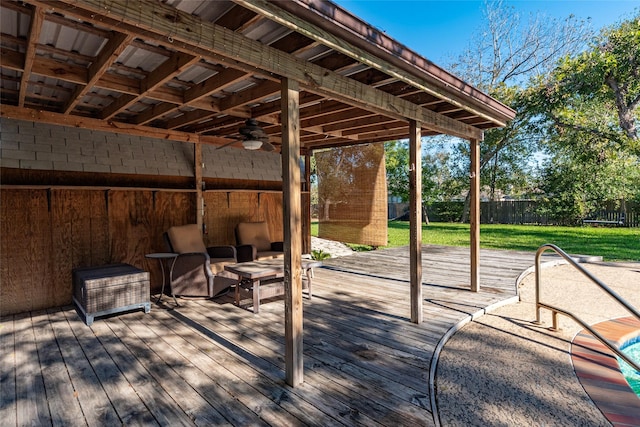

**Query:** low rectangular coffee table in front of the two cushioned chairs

left=224, top=259, right=322, bottom=314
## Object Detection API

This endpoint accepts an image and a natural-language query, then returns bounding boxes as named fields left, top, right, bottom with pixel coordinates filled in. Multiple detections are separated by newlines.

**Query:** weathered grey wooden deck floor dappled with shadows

left=0, top=246, right=534, bottom=426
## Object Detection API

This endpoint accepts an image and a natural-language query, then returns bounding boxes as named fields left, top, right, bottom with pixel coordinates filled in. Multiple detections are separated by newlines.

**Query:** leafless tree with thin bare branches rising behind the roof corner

left=444, top=1, right=590, bottom=221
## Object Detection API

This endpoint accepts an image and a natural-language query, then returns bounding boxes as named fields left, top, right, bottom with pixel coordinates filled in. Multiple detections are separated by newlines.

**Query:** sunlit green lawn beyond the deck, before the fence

left=311, top=221, right=640, bottom=261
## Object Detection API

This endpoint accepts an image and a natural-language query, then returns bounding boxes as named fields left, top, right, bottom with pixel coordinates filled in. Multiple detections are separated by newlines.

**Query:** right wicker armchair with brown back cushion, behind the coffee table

left=236, top=221, right=284, bottom=262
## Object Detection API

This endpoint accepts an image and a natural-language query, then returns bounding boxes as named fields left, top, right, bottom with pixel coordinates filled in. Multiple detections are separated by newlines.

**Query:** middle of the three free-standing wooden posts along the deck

left=409, top=120, right=422, bottom=323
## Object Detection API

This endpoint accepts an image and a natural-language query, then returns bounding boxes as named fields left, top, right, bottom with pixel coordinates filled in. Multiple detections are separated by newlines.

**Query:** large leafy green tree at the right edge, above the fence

left=522, top=11, right=640, bottom=224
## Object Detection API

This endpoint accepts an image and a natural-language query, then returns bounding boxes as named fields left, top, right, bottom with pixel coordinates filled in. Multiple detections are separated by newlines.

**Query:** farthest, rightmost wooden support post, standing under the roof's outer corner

left=469, top=139, right=480, bottom=292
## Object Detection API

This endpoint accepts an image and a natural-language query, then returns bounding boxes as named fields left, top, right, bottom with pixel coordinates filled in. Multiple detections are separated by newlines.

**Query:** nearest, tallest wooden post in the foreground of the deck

left=281, top=78, right=303, bottom=387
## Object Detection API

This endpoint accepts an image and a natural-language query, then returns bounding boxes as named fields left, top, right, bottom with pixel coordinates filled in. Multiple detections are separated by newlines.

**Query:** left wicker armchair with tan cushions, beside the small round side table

left=164, top=224, right=238, bottom=298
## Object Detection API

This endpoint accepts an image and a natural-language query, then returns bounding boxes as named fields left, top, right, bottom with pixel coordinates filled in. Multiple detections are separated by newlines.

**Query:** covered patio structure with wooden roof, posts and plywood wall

left=0, top=0, right=515, bottom=398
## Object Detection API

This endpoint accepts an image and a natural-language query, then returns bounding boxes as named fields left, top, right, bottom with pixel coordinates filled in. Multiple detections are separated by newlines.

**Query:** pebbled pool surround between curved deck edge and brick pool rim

left=436, top=263, right=640, bottom=426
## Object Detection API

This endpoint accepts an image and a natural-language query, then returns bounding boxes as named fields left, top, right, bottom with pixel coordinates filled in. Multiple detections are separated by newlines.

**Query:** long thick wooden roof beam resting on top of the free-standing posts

left=41, top=0, right=482, bottom=139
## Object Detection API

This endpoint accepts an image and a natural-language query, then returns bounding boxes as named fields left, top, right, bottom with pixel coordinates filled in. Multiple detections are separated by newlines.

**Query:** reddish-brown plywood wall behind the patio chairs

left=0, top=188, right=290, bottom=315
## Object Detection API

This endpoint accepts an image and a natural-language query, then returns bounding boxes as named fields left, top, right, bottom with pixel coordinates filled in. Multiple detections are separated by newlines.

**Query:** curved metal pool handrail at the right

left=535, top=243, right=640, bottom=372
